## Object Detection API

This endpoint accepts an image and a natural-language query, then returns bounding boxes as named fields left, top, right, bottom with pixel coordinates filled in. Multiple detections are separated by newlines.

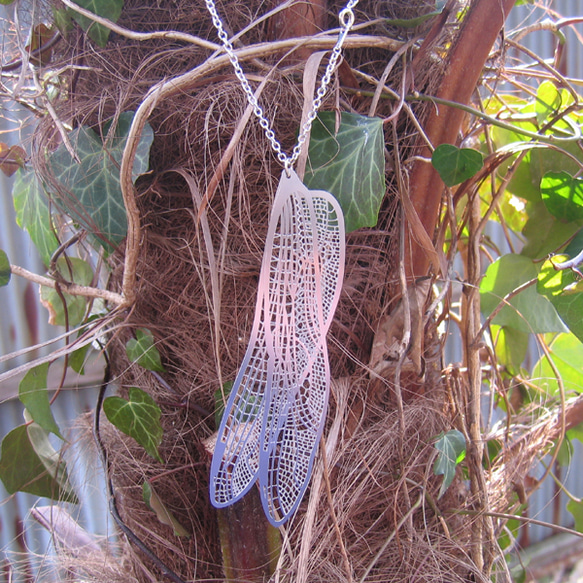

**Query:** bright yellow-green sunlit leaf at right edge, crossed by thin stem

left=531, top=334, right=583, bottom=395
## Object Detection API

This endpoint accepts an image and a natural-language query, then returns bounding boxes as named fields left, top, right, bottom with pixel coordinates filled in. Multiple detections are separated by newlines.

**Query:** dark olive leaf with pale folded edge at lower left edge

left=0, top=423, right=78, bottom=504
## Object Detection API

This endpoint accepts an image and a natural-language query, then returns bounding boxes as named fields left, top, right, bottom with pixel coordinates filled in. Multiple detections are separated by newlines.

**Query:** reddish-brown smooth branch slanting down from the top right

left=407, top=0, right=515, bottom=277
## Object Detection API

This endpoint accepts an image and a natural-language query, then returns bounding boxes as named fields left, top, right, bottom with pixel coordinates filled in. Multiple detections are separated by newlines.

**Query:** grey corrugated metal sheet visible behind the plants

left=0, top=0, right=583, bottom=580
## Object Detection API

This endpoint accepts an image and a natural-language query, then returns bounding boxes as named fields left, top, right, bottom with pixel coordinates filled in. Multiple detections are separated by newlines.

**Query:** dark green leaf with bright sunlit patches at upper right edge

left=540, top=172, right=583, bottom=223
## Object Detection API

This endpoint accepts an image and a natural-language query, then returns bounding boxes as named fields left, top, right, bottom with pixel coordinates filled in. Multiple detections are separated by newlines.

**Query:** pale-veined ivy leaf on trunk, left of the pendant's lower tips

left=103, top=387, right=163, bottom=462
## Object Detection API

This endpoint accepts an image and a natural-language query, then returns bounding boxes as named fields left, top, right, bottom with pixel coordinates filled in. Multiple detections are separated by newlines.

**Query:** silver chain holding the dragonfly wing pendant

left=205, top=0, right=359, bottom=171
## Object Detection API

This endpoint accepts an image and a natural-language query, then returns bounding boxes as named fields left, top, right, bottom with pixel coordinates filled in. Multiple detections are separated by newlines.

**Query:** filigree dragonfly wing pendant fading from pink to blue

left=210, top=171, right=345, bottom=526
